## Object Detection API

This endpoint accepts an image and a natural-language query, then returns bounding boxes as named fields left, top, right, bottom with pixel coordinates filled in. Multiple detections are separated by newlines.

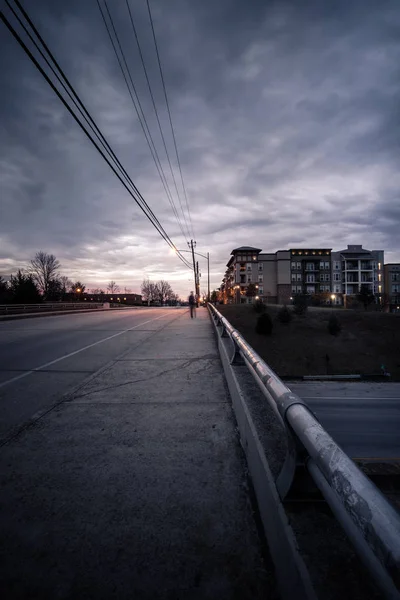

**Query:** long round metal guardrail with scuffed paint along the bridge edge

left=208, top=304, right=400, bottom=599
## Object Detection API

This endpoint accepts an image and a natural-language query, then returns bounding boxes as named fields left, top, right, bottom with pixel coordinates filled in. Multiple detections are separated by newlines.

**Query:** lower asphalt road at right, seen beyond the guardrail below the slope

left=287, top=382, right=400, bottom=462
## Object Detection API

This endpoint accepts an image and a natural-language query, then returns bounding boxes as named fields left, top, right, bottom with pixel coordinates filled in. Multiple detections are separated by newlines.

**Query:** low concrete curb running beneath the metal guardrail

left=209, top=312, right=316, bottom=600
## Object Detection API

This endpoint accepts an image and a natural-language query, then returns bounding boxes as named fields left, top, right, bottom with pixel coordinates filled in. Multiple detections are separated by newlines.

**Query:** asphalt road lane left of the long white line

left=0, top=308, right=184, bottom=444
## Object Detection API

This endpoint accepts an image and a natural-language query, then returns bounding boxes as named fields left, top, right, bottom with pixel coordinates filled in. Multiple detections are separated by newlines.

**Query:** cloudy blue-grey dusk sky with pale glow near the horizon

left=0, top=0, right=400, bottom=297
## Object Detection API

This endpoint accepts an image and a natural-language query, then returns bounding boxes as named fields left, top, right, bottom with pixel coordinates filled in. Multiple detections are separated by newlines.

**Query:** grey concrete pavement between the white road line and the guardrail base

left=0, top=308, right=278, bottom=600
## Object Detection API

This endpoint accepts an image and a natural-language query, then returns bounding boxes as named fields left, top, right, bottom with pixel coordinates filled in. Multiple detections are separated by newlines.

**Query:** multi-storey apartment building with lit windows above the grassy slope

left=221, top=245, right=384, bottom=304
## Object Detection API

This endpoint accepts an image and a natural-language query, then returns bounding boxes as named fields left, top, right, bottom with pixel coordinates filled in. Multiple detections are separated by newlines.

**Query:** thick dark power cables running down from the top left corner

left=0, top=0, right=191, bottom=268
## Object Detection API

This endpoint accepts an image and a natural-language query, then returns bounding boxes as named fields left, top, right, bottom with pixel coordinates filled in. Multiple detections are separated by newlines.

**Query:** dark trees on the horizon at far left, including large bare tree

left=0, top=250, right=131, bottom=304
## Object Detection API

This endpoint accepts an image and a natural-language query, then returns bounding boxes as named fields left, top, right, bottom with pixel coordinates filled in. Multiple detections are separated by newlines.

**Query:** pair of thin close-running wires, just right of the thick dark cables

left=97, top=0, right=186, bottom=244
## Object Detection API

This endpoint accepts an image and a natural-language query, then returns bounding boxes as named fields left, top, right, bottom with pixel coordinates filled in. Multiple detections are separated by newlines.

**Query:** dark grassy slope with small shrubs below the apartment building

left=217, top=304, right=400, bottom=381
